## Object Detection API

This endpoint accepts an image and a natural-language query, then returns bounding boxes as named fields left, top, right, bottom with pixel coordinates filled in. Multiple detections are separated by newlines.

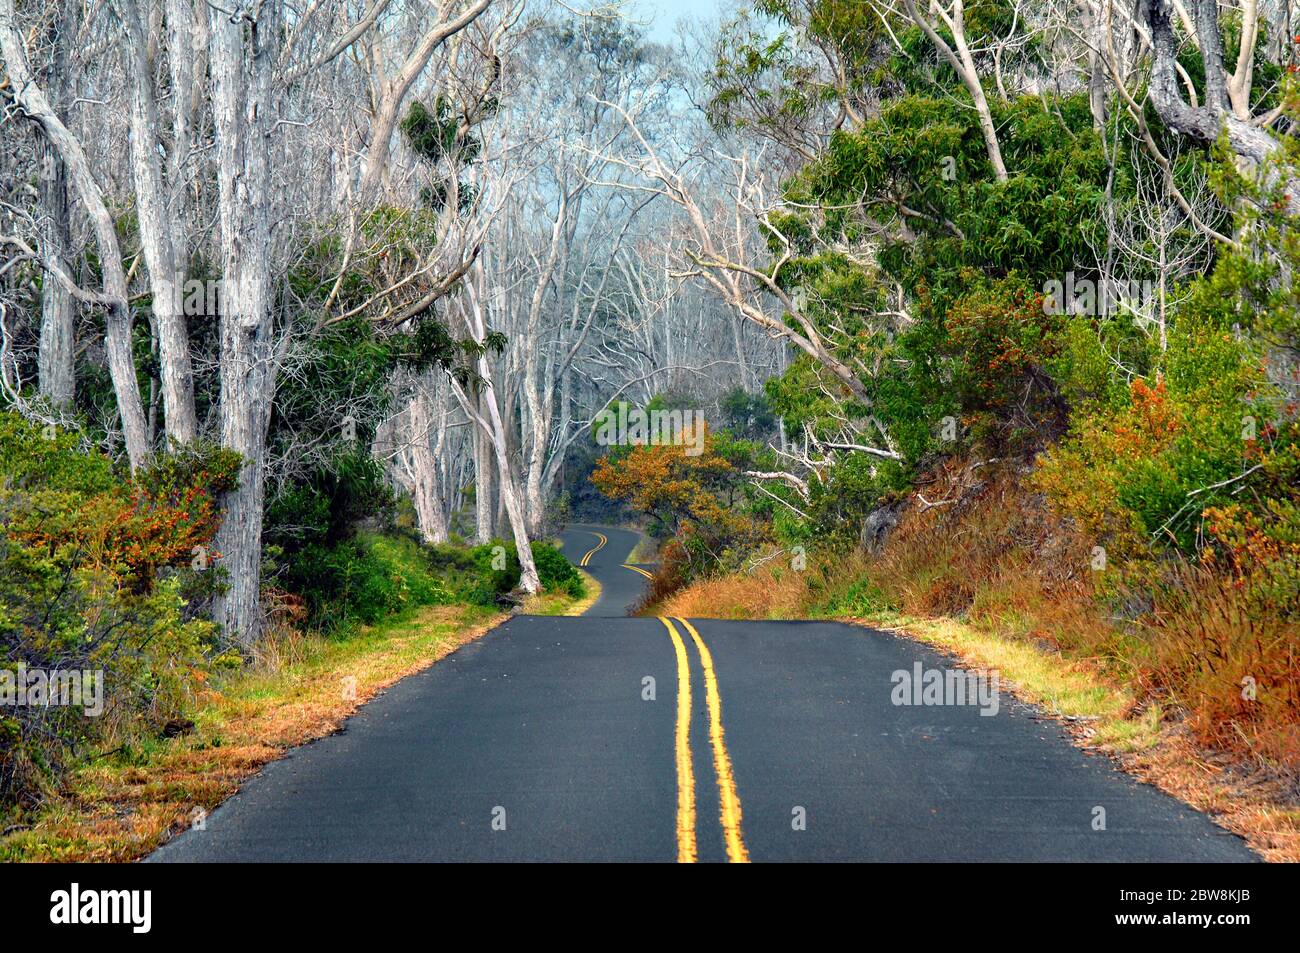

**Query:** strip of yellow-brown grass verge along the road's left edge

left=0, top=606, right=506, bottom=861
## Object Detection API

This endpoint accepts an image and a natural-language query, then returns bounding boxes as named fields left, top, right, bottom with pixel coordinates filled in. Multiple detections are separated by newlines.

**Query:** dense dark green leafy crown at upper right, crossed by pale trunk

left=787, top=95, right=1112, bottom=297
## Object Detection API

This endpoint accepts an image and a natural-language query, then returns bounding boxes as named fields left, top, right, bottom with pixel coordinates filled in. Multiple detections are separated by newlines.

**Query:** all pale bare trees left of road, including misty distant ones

left=0, top=0, right=781, bottom=634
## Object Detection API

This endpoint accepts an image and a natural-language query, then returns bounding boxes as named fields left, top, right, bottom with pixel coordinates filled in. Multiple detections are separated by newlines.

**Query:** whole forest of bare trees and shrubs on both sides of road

left=0, top=0, right=1300, bottom=857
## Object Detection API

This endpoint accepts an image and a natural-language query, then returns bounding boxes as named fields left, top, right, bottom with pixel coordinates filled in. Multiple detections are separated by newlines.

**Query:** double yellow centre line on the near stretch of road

left=660, top=613, right=749, bottom=863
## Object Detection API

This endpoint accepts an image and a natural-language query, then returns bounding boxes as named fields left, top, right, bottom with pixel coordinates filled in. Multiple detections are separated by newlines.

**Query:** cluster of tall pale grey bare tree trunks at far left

left=0, top=0, right=517, bottom=645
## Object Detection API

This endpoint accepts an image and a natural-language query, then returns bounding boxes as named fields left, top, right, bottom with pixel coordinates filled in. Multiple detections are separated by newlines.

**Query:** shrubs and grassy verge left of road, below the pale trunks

left=0, top=412, right=588, bottom=861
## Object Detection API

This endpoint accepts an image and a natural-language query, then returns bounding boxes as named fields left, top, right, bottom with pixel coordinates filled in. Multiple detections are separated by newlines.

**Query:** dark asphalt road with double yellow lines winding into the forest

left=148, top=525, right=1256, bottom=862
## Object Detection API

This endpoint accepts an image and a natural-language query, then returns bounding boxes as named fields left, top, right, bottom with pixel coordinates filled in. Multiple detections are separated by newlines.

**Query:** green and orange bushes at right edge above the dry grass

left=1040, top=147, right=1300, bottom=603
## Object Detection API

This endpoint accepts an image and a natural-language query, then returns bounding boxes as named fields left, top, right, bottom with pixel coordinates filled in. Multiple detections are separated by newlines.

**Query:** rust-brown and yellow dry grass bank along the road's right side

left=653, top=463, right=1300, bottom=861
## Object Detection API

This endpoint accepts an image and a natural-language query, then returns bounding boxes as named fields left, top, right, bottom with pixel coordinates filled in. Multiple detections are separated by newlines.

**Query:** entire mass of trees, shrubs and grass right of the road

left=593, top=3, right=1300, bottom=854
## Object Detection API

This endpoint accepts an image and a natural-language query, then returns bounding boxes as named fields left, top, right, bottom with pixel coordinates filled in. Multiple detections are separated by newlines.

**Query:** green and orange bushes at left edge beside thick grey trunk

left=0, top=412, right=224, bottom=809
